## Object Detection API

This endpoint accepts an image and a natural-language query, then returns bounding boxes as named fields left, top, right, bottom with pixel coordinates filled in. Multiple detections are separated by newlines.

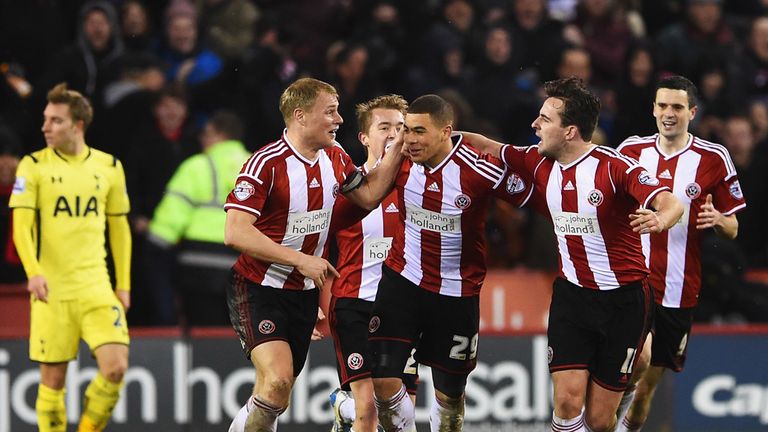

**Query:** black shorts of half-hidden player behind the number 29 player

left=328, top=297, right=419, bottom=394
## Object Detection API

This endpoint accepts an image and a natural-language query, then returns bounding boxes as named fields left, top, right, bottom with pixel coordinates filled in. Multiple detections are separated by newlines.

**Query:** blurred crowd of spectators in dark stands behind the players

left=0, top=0, right=768, bottom=325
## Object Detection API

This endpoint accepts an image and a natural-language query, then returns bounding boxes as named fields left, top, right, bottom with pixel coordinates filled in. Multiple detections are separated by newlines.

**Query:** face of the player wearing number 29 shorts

left=404, top=113, right=452, bottom=167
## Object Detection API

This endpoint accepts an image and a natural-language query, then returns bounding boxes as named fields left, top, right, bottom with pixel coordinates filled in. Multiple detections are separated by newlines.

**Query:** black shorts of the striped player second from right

left=547, top=278, right=653, bottom=392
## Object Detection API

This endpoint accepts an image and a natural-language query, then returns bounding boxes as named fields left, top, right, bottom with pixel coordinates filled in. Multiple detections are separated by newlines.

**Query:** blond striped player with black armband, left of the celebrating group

left=224, top=78, right=403, bottom=431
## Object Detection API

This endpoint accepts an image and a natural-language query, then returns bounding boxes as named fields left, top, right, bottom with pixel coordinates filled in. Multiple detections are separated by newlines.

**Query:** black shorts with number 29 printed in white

left=368, top=266, right=480, bottom=378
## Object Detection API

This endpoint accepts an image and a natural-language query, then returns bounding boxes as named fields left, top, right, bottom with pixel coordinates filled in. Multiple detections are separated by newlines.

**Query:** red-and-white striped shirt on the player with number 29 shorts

left=386, top=135, right=531, bottom=297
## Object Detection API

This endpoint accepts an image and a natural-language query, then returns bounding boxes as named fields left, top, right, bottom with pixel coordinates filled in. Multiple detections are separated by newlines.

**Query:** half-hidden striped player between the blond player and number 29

left=329, top=95, right=416, bottom=432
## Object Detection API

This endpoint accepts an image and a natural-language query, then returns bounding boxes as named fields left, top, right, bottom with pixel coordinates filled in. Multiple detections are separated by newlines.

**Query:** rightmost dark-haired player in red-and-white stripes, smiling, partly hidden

left=617, top=76, right=746, bottom=431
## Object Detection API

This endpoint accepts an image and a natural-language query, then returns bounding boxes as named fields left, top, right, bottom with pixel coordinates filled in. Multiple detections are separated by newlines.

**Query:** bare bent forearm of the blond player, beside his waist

left=224, top=209, right=339, bottom=288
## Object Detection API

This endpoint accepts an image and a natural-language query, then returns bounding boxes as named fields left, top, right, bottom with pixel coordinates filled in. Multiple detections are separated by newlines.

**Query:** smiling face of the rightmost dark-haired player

left=653, top=88, right=696, bottom=141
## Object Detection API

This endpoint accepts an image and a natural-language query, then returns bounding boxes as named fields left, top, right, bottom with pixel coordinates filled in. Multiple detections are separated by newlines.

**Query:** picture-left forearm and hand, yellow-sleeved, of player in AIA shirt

left=13, top=208, right=48, bottom=302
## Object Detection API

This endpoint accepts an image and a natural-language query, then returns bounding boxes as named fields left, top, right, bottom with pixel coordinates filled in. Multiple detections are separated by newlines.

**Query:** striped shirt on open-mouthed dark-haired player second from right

left=502, top=145, right=669, bottom=290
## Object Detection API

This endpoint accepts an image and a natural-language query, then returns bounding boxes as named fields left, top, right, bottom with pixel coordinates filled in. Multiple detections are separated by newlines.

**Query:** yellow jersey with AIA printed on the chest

left=9, top=147, right=130, bottom=300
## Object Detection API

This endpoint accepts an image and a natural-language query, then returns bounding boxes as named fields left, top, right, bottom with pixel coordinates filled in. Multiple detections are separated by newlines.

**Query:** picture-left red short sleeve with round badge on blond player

left=224, top=158, right=275, bottom=217
